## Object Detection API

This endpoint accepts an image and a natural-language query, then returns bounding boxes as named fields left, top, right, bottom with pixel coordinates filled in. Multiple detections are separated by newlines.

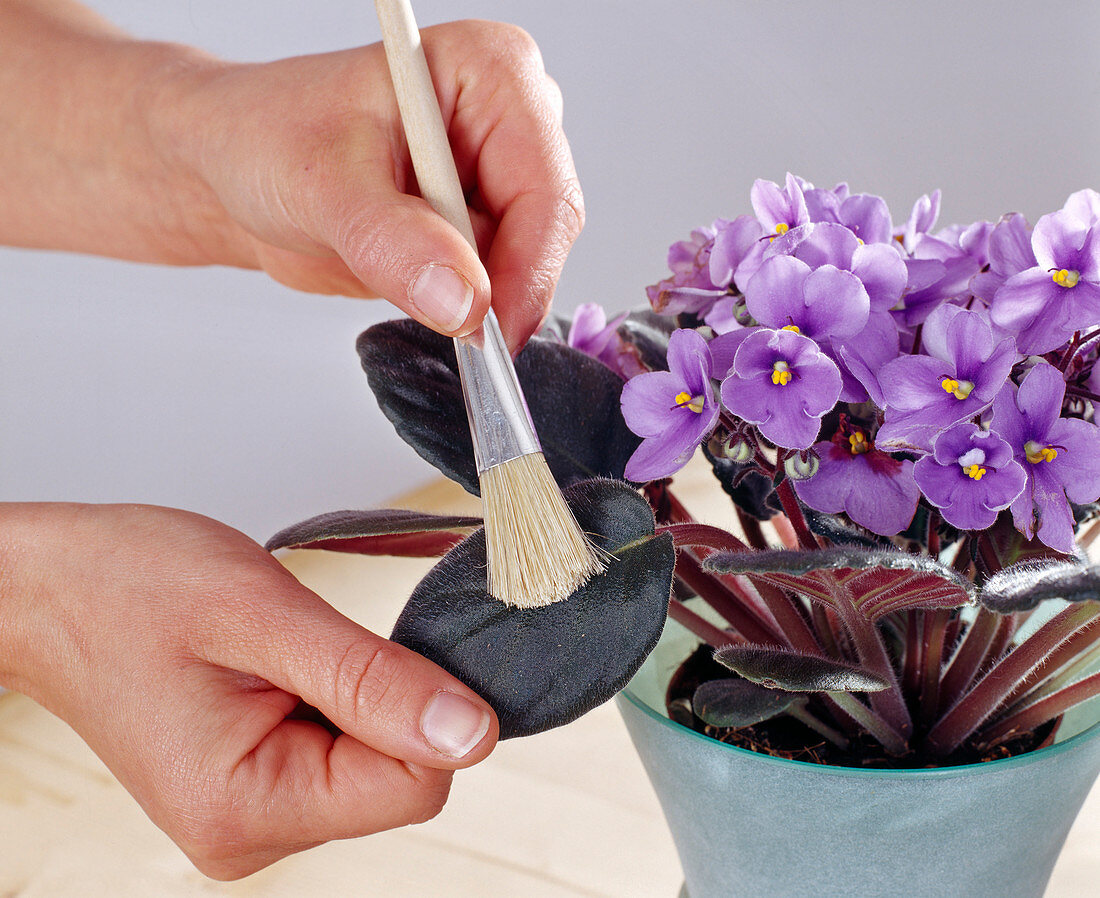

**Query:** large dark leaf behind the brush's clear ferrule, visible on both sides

left=356, top=319, right=640, bottom=495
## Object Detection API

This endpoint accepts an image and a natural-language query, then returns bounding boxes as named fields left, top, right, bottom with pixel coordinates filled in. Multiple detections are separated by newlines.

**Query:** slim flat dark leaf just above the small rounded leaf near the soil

left=714, top=645, right=890, bottom=692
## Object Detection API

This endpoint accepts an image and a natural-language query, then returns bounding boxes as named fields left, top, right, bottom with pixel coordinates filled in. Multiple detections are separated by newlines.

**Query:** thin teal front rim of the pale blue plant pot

left=617, top=683, right=1100, bottom=779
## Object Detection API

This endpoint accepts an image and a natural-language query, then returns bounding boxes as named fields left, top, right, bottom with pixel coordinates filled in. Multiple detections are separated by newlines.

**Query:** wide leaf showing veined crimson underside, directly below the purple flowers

left=703, top=546, right=974, bottom=621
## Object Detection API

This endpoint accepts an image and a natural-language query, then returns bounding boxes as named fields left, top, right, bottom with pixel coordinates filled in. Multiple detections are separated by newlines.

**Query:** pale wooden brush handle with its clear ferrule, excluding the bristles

left=374, top=0, right=541, bottom=474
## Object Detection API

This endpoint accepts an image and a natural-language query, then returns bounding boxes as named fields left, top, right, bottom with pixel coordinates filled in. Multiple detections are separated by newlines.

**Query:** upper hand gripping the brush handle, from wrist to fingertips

left=160, top=22, right=584, bottom=349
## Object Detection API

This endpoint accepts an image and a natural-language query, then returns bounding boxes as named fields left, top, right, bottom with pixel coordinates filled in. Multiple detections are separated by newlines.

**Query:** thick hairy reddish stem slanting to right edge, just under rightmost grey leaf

left=926, top=602, right=1100, bottom=756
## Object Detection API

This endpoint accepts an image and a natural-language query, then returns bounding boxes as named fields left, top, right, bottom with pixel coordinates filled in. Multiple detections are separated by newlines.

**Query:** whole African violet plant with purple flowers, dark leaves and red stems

left=270, top=175, right=1100, bottom=766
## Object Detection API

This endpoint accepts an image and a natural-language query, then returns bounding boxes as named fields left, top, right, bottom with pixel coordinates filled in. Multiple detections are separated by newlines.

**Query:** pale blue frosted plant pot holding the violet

left=617, top=621, right=1100, bottom=898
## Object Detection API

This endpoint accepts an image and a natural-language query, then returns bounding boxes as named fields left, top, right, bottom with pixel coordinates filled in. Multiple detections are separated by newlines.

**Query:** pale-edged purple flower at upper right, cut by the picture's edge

left=990, top=190, right=1100, bottom=354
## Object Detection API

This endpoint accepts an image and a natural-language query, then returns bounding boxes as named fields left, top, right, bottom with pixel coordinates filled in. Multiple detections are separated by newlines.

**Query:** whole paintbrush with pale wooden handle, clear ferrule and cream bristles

left=375, top=0, right=604, bottom=607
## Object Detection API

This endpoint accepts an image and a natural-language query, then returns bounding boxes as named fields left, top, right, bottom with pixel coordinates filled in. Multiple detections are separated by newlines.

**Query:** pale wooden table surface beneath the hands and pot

left=0, top=468, right=1100, bottom=898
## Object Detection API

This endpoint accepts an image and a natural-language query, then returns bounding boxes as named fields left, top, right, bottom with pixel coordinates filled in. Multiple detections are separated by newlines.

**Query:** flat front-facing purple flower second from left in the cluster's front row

left=722, top=328, right=840, bottom=449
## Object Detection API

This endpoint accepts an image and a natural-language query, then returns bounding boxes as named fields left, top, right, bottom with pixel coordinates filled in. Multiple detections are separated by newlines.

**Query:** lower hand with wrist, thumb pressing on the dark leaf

left=0, top=504, right=497, bottom=879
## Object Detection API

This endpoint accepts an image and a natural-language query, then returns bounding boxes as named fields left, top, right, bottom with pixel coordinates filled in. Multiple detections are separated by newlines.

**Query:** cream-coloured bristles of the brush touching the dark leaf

left=481, top=452, right=606, bottom=607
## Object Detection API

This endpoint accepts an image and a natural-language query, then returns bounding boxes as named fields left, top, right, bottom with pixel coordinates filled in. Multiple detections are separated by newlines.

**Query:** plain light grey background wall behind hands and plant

left=0, top=0, right=1100, bottom=539
